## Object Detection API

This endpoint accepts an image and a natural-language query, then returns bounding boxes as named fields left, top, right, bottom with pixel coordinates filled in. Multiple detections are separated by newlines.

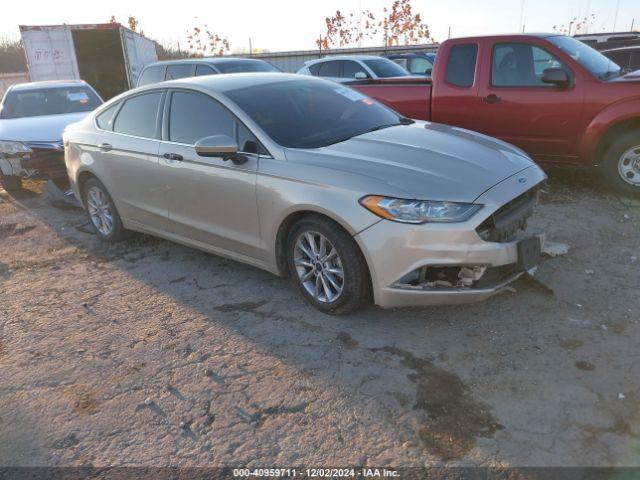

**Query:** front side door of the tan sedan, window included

left=160, top=90, right=264, bottom=259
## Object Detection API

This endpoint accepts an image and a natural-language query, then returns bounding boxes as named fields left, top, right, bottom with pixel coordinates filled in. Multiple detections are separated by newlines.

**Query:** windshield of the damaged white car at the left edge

left=0, top=87, right=102, bottom=118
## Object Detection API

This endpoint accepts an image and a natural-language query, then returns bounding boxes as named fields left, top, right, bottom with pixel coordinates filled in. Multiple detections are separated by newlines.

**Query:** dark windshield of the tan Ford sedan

left=226, top=80, right=408, bottom=148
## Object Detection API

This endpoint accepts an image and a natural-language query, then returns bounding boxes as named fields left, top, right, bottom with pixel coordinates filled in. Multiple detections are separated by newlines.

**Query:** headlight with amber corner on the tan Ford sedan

left=360, top=195, right=482, bottom=223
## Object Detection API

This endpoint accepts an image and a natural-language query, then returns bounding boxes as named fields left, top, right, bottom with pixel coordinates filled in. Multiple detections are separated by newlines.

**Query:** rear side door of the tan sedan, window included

left=97, top=90, right=168, bottom=230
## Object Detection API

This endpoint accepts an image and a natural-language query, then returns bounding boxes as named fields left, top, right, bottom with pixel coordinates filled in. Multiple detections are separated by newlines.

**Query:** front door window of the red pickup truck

left=491, top=43, right=571, bottom=87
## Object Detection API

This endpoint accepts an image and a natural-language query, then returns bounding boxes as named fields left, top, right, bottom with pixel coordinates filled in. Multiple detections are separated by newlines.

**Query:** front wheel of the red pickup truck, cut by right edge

left=603, top=132, right=640, bottom=196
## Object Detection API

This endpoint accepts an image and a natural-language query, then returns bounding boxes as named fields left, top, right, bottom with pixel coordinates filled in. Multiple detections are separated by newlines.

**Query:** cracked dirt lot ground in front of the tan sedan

left=0, top=171, right=640, bottom=467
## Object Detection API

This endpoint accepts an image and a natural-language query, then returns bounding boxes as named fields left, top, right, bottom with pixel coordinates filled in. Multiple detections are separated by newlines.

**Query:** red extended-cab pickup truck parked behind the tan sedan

left=349, top=34, right=640, bottom=195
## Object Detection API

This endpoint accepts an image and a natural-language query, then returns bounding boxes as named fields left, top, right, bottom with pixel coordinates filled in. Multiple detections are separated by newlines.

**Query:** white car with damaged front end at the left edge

left=0, top=80, right=102, bottom=191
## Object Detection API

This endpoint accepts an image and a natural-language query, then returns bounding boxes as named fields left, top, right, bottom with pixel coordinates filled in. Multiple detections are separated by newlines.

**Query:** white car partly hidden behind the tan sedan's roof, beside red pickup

left=298, top=55, right=410, bottom=83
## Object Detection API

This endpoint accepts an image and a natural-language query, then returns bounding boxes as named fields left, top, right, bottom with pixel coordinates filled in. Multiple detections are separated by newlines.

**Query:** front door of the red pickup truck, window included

left=477, top=42, right=584, bottom=162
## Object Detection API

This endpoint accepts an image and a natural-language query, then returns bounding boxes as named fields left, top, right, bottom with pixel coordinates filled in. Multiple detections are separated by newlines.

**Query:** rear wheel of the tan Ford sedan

left=82, top=178, right=129, bottom=242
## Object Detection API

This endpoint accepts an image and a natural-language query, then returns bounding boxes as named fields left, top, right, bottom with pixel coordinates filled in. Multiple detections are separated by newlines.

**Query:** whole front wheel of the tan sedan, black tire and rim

left=287, top=215, right=371, bottom=315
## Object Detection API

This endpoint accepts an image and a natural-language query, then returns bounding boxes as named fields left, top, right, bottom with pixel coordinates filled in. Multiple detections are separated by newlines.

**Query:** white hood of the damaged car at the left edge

left=0, top=112, right=91, bottom=142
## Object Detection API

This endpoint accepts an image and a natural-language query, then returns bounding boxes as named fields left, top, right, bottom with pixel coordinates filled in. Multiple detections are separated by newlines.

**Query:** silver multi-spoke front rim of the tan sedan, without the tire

left=293, top=231, right=344, bottom=303
